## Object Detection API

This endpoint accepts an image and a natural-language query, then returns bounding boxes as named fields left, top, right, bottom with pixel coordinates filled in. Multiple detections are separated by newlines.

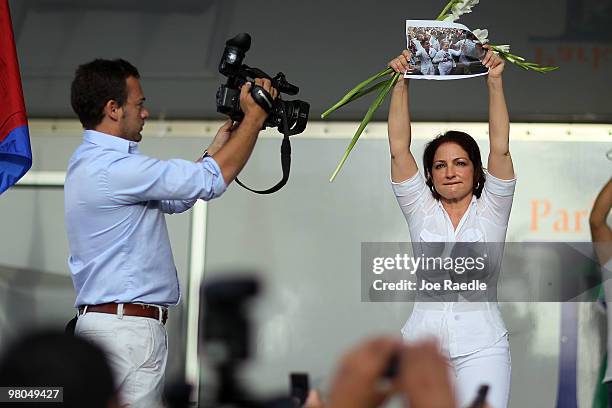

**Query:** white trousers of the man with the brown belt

left=75, top=312, right=168, bottom=408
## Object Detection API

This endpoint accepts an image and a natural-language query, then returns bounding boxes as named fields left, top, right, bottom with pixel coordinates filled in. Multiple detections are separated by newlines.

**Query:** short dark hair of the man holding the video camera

left=70, top=59, right=140, bottom=129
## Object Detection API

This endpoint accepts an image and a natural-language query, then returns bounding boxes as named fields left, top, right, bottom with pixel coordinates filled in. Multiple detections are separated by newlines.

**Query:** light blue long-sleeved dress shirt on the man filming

left=64, top=130, right=226, bottom=307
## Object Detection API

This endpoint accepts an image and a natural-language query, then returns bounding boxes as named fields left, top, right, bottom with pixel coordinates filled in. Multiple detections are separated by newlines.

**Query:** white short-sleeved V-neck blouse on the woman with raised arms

left=392, top=173, right=516, bottom=358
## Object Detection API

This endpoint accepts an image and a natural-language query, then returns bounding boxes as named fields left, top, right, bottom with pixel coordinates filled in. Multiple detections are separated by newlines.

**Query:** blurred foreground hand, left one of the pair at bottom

left=328, top=337, right=402, bottom=408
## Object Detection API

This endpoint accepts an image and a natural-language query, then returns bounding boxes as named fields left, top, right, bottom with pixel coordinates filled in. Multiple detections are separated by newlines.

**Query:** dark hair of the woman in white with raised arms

left=423, top=130, right=485, bottom=200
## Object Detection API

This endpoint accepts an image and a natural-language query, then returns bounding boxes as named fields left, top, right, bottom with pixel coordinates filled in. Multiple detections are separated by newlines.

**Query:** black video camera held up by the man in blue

left=217, top=33, right=310, bottom=136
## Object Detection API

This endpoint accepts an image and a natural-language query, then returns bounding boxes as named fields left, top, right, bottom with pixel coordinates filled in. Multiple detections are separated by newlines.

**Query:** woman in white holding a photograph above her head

left=388, top=47, right=516, bottom=408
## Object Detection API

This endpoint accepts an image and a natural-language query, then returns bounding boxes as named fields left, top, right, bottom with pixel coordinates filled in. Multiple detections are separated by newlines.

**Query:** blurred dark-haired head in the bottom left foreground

left=0, top=331, right=116, bottom=408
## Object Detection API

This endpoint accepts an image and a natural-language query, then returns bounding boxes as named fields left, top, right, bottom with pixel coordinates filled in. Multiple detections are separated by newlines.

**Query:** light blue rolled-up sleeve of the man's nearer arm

left=101, top=154, right=227, bottom=204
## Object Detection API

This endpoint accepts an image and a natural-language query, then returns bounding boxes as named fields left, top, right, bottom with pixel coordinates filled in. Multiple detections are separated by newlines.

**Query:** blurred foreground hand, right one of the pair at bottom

left=399, top=341, right=457, bottom=408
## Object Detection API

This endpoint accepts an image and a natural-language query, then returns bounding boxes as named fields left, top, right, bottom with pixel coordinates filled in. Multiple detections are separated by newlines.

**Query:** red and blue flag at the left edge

left=0, top=0, right=32, bottom=194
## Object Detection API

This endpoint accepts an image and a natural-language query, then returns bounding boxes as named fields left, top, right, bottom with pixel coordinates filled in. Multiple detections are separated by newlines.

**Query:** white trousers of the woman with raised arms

left=450, top=335, right=512, bottom=408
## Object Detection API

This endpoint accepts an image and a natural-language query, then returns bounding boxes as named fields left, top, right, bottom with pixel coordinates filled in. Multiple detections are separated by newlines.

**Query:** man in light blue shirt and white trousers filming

left=64, top=59, right=277, bottom=407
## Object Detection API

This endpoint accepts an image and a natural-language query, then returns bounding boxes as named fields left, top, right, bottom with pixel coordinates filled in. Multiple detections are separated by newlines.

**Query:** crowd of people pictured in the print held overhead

left=406, top=27, right=487, bottom=76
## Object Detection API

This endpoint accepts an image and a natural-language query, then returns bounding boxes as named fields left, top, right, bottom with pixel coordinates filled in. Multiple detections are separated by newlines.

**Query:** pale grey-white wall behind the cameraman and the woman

left=0, top=121, right=612, bottom=407
